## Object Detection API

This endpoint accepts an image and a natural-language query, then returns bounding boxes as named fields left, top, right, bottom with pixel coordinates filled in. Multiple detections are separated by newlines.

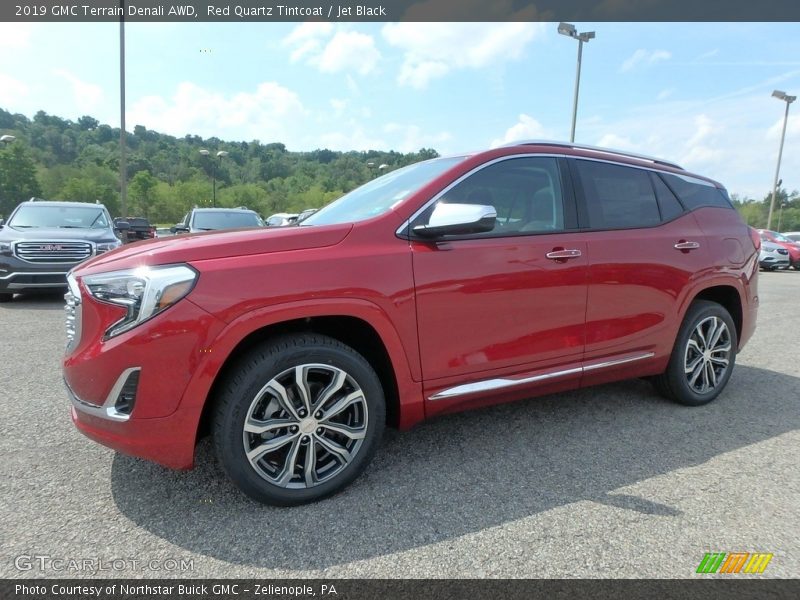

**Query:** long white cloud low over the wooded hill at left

left=127, top=82, right=307, bottom=142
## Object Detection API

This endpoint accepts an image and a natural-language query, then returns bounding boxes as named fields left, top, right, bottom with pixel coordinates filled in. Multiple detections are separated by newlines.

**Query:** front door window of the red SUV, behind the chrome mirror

left=424, top=157, right=564, bottom=238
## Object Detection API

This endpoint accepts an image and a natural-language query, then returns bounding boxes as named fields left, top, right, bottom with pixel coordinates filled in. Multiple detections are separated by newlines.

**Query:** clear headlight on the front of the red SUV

left=83, top=265, right=197, bottom=339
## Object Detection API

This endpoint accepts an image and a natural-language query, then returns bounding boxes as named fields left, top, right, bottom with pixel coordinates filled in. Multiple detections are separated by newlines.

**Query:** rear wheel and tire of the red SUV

left=653, top=300, right=738, bottom=406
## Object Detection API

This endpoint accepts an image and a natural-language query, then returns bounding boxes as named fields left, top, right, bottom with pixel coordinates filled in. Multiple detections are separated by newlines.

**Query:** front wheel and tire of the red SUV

left=212, top=334, right=386, bottom=506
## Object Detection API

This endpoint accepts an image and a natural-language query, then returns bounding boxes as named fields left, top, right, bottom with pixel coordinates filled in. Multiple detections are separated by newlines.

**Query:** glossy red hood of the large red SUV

left=79, top=223, right=353, bottom=275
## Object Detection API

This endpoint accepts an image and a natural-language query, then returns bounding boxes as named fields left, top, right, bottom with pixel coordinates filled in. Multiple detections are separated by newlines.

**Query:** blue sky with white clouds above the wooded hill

left=0, top=23, right=800, bottom=199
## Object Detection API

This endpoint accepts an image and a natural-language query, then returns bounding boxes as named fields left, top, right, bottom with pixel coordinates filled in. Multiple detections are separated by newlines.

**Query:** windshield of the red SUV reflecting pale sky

left=301, top=156, right=466, bottom=227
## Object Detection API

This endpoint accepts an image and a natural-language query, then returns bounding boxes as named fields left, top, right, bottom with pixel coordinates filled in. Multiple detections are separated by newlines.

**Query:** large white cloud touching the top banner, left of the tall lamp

left=382, top=22, right=544, bottom=89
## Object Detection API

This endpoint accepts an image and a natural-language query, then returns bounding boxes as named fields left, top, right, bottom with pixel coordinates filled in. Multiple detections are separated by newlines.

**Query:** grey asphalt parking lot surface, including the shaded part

left=0, top=271, right=800, bottom=578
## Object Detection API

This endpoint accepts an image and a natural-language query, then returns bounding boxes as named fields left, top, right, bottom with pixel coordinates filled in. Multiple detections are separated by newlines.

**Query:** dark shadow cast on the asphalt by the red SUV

left=112, top=366, right=800, bottom=569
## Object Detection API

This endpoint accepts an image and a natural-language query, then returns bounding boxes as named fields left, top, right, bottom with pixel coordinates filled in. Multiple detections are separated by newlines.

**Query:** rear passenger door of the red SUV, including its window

left=571, top=159, right=708, bottom=370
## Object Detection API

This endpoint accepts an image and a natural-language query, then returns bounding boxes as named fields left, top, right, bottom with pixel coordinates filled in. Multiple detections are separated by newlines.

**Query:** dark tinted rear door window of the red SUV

left=575, top=160, right=661, bottom=229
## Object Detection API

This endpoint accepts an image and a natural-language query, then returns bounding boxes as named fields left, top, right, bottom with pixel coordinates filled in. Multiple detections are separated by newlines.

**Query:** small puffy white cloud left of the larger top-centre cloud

left=282, top=23, right=381, bottom=75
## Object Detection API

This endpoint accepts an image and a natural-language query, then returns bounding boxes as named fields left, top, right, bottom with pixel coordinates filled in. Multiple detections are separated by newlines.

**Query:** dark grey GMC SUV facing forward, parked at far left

left=0, top=199, right=127, bottom=302
